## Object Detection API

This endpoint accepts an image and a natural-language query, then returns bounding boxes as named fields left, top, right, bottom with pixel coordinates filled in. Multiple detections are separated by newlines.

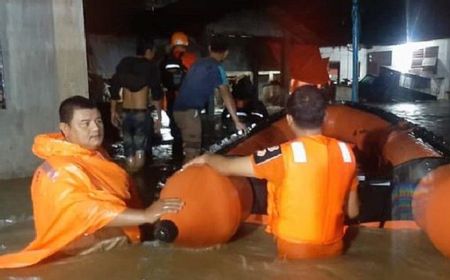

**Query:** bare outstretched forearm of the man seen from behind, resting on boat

left=183, top=154, right=255, bottom=177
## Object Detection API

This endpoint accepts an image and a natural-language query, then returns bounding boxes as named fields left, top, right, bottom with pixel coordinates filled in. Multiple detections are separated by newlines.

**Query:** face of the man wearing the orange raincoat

left=59, top=109, right=104, bottom=150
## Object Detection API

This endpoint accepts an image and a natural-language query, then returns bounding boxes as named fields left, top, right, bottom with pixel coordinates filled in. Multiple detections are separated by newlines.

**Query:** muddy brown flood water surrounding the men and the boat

left=0, top=102, right=450, bottom=280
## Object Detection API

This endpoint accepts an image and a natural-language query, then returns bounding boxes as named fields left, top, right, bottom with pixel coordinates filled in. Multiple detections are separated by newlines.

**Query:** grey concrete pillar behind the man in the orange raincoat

left=0, top=0, right=87, bottom=179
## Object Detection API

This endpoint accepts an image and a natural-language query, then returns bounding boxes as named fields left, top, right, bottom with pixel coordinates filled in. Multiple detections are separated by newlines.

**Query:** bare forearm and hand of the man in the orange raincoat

left=106, top=198, right=184, bottom=227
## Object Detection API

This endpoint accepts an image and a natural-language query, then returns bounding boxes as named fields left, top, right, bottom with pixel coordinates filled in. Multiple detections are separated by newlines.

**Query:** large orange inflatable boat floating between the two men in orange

left=156, top=104, right=450, bottom=257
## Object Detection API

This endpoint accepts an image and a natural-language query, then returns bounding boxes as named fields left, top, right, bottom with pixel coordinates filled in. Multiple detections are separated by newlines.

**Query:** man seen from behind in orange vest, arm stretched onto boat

left=187, top=86, right=358, bottom=259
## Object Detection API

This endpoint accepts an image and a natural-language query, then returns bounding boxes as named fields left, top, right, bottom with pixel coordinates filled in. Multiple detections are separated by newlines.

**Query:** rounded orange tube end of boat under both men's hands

left=156, top=166, right=253, bottom=247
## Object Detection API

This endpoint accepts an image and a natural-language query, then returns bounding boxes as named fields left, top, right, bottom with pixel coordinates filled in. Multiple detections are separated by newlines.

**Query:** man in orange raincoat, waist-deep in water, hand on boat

left=0, top=96, right=183, bottom=268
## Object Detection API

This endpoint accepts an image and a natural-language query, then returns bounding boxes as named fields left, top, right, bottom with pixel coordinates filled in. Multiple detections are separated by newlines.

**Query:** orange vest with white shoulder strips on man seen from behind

left=268, top=135, right=356, bottom=244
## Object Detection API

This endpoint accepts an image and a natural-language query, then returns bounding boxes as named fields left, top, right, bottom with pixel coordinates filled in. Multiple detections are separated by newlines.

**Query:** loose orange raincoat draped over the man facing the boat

left=0, top=133, right=136, bottom=268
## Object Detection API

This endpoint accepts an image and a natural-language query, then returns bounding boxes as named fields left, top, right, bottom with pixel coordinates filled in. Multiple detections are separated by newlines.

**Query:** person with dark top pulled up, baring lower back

left=111, top=39, right=162, bottom=172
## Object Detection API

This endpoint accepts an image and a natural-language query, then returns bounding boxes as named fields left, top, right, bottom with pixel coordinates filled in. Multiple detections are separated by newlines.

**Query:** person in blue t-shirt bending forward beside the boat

left=173, top=38, right=245, bottom=161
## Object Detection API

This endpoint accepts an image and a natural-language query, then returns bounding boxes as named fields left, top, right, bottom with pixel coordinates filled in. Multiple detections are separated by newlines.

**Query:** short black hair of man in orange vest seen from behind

left=286, top=85, right=327, bottom=129
